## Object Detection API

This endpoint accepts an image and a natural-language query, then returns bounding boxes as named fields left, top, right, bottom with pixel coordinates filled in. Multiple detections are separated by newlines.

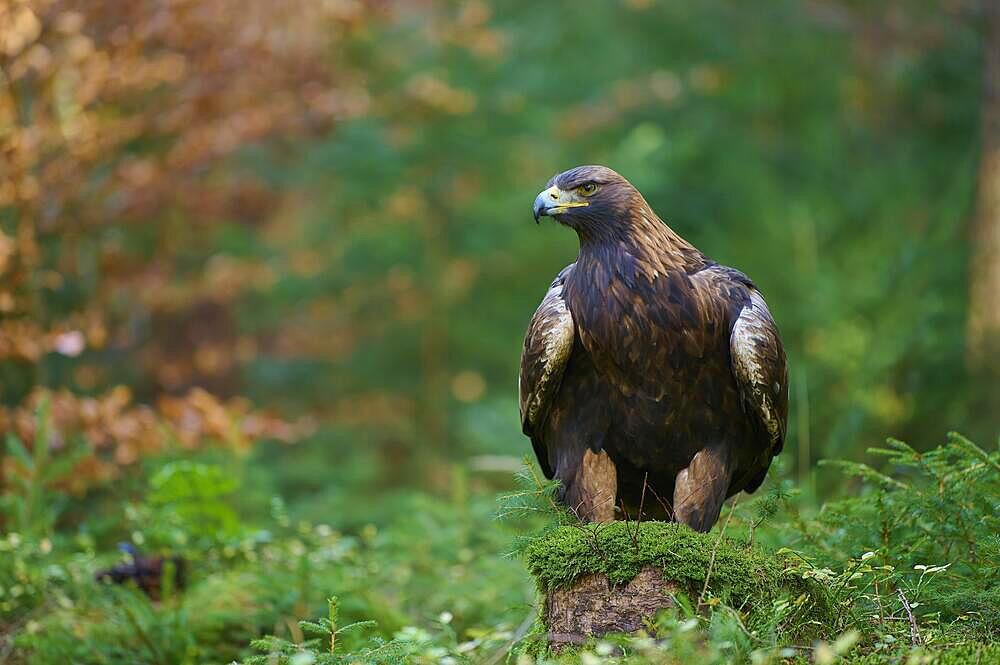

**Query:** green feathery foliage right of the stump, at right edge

left=779, top=434, right=1000, bottom=640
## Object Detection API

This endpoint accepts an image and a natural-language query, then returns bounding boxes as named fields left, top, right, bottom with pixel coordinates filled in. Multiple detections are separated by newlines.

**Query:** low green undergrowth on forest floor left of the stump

left=7, top=444, right=531, bottom=665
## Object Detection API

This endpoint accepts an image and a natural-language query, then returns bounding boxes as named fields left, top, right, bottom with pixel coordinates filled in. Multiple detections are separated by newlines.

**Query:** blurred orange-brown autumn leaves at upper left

left=0, top=0, right=368, bottom=490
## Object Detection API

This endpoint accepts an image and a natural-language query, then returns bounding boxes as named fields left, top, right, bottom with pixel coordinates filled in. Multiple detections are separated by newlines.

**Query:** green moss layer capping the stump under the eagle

left=524, top=521, right=833, bottom=634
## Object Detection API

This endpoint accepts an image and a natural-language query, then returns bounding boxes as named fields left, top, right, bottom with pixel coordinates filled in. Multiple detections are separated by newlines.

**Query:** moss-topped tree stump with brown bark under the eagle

left=525, top=522, right=832, bottom=649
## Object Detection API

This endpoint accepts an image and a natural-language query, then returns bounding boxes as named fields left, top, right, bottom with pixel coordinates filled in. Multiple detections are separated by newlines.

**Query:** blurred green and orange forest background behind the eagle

left=0, top=0, right=1000, bottom=662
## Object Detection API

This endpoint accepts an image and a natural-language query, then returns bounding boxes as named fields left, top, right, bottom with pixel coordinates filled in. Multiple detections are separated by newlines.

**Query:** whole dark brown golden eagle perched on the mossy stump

left=519, top=166, right=788, bottom=531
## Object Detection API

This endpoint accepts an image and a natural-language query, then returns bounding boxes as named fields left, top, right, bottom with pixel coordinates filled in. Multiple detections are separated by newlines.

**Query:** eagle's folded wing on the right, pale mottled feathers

left=729, top=287, right=788, bottom=460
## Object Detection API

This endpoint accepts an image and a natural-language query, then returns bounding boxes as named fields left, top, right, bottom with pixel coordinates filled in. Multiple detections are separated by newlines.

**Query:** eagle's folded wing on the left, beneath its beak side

left=517, top=263, right=576, bottom=478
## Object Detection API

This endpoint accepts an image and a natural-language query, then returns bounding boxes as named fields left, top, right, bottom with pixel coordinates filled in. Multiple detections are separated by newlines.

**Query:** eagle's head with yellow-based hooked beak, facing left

left=534, top=166, right=646, bottom=233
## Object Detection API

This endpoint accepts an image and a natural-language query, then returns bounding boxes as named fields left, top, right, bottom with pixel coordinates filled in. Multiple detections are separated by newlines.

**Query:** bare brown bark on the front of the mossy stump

left=545, top=566, right=678, bottom=649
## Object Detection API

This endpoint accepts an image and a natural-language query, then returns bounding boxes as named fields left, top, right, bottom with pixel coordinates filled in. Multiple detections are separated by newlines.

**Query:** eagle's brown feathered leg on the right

left=674, top=445, right=733, bottom=532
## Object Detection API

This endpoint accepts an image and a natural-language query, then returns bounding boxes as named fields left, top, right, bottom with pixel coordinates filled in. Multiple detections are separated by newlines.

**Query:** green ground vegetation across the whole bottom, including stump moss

left=0, top=420, right=998, bottom=665
